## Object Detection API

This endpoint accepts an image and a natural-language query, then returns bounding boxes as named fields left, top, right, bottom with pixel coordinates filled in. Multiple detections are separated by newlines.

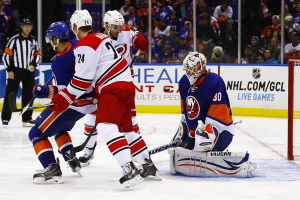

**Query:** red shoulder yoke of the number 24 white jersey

left=75, top=33, right=109, bottom=50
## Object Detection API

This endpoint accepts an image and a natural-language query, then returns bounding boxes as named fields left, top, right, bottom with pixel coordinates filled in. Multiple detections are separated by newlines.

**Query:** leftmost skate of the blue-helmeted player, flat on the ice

left=33, top=163, right=64, bottom=184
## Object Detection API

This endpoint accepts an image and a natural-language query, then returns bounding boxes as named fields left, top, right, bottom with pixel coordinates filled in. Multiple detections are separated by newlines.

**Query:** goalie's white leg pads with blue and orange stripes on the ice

left=168, top=147, right=260, bottom=177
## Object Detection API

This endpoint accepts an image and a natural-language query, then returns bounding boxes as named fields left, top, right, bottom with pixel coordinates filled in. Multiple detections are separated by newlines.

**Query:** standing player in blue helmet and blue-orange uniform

left=29, top=21, right=96, bottom=183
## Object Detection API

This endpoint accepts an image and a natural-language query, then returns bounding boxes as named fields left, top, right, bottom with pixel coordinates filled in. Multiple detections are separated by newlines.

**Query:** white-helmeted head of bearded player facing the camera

left=103, top=10, right=125, bottom=35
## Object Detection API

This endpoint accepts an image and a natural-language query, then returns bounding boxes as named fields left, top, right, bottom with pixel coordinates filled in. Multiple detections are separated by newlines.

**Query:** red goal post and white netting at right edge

left=288, top=57, right=300, bottom=160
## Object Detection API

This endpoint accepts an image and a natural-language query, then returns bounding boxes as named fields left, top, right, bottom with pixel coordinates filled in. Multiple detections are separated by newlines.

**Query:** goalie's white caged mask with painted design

left=183, top=52, right=206, bottom=85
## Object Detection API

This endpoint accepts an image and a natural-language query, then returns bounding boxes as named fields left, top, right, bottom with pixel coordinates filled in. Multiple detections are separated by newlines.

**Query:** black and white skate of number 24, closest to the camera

left=119, top=162, right=144, bottom=188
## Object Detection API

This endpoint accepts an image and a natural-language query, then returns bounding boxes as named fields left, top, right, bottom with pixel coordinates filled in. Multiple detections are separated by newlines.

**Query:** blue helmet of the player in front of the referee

left=45, top=21, right=69, bottom=43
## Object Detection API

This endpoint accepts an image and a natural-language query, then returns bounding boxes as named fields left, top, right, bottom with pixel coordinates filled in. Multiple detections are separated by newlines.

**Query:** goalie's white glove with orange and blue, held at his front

left=194, top=120, right=219, bottom=152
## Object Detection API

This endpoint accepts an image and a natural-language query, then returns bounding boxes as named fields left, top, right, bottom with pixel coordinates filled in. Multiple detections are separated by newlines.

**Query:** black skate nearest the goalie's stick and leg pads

left=140, top=157, right=162, bottom=181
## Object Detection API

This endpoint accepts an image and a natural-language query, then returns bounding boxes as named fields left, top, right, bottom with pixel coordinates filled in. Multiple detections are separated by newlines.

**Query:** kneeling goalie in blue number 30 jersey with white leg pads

left=169, top=52, right=259, bottom=177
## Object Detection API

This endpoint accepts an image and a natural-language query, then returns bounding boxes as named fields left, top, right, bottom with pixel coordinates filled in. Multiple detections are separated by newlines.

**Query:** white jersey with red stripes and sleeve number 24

left=67, top=33, right=132, bottom=98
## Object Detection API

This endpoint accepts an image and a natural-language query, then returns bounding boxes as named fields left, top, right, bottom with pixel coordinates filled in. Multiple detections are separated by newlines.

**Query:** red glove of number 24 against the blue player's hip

left=49, top=88, right=76, bottom=112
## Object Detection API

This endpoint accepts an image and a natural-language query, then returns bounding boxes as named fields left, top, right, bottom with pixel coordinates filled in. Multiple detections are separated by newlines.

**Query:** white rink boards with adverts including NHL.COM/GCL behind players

left=0, top=64, right=288, bottom=117
